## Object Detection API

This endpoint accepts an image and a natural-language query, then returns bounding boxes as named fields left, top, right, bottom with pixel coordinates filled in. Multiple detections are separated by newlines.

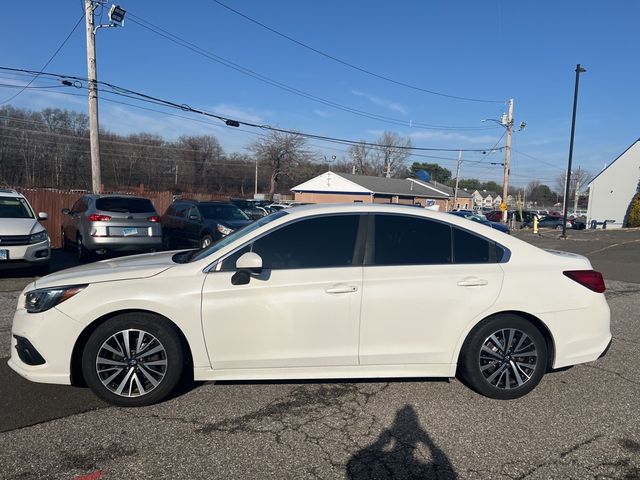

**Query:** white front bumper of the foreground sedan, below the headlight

left=8, top=302, right=84, bottom=385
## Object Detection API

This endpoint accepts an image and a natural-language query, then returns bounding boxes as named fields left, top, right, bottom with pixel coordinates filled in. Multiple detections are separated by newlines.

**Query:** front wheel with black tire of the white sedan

left=82, top=312, right=185, bottom=407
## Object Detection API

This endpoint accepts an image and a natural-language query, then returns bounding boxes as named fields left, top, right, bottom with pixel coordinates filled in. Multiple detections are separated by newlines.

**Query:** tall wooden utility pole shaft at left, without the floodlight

left=84, top=0, right=102, bottom=193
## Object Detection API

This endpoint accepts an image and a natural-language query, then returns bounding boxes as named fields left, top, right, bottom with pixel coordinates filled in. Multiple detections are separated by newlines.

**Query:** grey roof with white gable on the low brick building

left=291, top=172, right=453, bottom=198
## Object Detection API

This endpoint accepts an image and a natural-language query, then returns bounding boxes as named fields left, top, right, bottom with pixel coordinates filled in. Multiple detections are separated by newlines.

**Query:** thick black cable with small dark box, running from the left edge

left=0, top=66, right=504, bottom=152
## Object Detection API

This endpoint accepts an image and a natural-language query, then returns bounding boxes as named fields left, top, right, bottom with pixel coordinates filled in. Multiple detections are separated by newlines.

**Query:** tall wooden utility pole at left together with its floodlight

left=84, top=0, right=126, bottom=193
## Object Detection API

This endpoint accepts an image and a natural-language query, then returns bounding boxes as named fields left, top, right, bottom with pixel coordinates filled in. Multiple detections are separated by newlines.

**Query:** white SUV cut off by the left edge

left=0, top=188, right=51, bottom=273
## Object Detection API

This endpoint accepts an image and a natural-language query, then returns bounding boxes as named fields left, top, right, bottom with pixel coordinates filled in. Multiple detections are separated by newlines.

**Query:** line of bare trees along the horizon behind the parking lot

left=0, top=105, right=592, bottom=203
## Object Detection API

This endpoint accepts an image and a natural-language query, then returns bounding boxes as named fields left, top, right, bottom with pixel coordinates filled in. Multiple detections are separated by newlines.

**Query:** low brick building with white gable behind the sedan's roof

left=291, top=172, right=468, bottom=210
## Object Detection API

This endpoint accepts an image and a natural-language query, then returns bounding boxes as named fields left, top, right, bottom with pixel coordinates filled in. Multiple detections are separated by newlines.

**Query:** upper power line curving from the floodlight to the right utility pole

left=127, top=12, right=495, bottom=130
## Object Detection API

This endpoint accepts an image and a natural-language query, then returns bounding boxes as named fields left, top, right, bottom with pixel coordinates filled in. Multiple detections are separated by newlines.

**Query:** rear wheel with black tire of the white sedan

left=460, top=314, right=548, bottom=400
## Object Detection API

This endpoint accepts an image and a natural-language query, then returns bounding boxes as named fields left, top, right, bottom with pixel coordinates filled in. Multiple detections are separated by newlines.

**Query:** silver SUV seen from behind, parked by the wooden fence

left=61, top=194, right=162, bottom=261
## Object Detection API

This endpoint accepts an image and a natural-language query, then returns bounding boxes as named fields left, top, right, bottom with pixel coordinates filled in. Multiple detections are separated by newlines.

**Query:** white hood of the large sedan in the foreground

left=35, top=252, right=176, bottom=288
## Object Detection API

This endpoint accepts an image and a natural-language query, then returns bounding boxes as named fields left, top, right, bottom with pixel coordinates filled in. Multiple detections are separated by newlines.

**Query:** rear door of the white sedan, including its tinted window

left=360, top=214, right=503, bottom=365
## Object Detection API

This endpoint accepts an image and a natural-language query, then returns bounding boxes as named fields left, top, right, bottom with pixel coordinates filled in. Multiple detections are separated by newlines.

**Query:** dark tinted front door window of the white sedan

left=252, top=215, right=360, bottom=270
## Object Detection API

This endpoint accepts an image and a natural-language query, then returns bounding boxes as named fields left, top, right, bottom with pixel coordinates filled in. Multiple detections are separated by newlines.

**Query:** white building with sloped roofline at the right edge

left=587, top=139, right=640, bottom=228
